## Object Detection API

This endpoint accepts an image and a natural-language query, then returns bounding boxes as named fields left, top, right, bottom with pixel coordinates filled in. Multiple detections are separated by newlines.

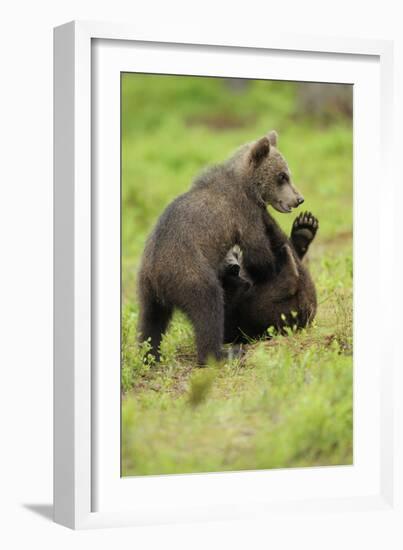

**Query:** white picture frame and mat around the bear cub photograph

left=54, top=22, right=403, bottom=528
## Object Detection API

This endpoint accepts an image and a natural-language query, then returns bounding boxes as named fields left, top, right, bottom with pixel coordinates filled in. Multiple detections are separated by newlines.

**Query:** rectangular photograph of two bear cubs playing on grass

left=120, top=72, right=353, bottom=477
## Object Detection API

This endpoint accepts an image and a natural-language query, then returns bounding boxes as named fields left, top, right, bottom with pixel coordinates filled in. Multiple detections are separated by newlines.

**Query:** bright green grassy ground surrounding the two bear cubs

left=122, top=75, right=352, bottom=475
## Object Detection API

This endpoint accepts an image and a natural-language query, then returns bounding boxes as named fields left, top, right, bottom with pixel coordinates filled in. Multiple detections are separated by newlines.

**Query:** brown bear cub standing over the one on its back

left=139, top=131, right=304, bottom=364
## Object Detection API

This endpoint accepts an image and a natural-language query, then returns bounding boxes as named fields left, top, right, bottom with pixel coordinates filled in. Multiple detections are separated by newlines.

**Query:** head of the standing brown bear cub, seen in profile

left=248, top=130, right=304, bottom=212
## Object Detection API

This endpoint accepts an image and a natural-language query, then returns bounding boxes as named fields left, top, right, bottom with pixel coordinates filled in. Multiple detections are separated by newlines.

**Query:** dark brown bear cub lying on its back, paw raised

left=221, top=212, right=319, bottom=342
